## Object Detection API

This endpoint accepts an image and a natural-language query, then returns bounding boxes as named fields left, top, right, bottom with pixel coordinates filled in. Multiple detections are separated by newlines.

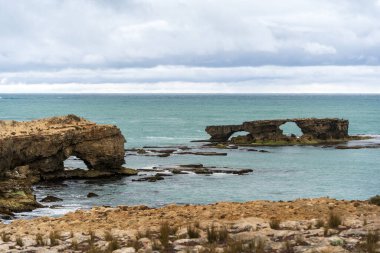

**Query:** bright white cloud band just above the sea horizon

left=0, top=66, right=380, bottom=93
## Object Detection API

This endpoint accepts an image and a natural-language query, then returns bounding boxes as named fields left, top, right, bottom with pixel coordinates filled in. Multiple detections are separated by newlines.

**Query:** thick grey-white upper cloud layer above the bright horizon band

left=0, top=0, right=380, bottom=69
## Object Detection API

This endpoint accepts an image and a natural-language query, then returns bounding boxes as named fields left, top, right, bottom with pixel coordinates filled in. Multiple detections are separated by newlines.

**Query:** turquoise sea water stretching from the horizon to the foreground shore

left=0, top=94, right=380, bottom=217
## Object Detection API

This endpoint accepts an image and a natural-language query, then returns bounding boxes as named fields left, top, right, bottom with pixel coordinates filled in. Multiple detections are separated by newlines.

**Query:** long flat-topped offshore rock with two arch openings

left=206, top=118, right=349, bottom=142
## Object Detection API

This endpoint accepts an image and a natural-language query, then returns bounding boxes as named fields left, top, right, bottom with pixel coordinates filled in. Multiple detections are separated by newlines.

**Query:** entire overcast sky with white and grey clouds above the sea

left=0, top=0, right=380, bottom=93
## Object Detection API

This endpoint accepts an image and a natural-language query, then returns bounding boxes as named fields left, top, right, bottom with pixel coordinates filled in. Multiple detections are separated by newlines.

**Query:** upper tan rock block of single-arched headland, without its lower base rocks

left=0, top=115, right=125, bottom=178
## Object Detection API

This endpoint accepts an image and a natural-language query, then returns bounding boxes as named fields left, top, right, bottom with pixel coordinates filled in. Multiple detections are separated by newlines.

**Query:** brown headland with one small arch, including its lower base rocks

left=0, top=115, right=132, bottom=213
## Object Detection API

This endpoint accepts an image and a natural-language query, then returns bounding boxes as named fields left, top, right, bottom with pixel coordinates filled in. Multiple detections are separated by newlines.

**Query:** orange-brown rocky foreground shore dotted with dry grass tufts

left=0, top=197, right=380, bottom=253
